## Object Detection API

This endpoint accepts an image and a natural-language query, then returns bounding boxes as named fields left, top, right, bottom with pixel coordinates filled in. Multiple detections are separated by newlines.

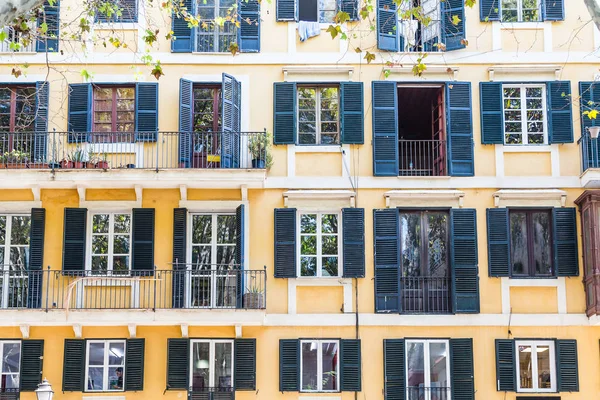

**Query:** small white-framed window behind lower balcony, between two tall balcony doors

left=90, top=213, right=131, bottom=274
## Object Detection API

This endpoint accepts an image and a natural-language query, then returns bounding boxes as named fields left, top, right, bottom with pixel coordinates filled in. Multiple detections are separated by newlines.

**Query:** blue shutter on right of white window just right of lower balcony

left=342, top=208, right=365, bottom=278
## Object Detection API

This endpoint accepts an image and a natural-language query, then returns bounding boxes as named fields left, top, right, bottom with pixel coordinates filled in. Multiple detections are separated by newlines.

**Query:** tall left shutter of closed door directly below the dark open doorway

left=373, top=208, right=400, bottom=312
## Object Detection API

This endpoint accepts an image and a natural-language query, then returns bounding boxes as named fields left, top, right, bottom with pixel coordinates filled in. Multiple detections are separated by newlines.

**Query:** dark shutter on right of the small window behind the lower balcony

left=131, top=208, right=154, bottom=272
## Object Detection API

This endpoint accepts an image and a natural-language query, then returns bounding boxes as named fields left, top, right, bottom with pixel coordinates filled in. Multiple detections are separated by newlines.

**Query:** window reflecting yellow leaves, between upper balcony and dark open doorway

left=298, top=86, right=340, bottom=144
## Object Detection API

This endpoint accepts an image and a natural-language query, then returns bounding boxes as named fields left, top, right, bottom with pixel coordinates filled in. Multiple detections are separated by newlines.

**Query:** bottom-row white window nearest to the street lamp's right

left=85, top=340, right=126, bottom=392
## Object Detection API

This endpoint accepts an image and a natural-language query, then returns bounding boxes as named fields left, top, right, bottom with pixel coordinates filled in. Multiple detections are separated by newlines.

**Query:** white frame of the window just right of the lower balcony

left=296, top=210, right=344, bottom=279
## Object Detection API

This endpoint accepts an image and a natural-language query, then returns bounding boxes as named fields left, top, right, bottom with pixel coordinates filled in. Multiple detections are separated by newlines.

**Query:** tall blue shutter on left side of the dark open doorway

left=372, top=81, right=400, bottom=176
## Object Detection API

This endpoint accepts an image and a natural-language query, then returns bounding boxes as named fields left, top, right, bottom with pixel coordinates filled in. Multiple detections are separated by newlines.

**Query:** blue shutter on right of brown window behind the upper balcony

left=135, top=82, right=158, bottom=142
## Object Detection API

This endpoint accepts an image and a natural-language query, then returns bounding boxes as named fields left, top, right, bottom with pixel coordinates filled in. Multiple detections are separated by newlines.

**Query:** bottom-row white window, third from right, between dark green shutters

left=300, top=340, right=340, bottom=392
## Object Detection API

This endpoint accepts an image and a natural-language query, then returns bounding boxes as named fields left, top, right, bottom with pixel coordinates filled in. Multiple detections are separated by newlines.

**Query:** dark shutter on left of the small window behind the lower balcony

left=63, top=208, right=87, bottom=271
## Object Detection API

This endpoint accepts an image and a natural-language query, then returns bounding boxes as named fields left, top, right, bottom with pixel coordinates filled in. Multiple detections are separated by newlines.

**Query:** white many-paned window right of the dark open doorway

left=502, top=84, right=548, bottom=145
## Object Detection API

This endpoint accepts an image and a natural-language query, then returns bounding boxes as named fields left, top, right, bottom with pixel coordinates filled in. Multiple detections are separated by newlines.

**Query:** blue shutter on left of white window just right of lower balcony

left=275, top=208, right=296, bottom=278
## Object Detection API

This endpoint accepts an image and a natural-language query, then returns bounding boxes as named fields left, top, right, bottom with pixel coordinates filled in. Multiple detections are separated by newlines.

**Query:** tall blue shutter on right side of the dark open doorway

left=446, top=82, right=475, bottom=176
